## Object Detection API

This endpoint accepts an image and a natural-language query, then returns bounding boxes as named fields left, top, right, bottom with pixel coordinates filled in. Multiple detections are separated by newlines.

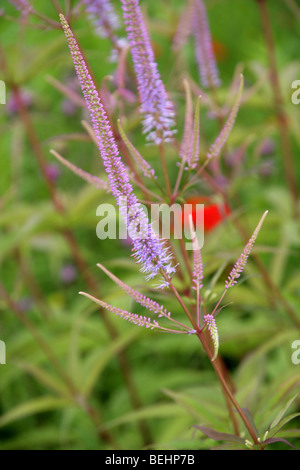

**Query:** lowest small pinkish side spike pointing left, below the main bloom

left=79, top=292, right=194, bottom=334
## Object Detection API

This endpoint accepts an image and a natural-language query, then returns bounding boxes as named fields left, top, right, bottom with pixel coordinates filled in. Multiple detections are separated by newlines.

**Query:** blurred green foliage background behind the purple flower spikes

left=0, top=0, right=300, bottom=449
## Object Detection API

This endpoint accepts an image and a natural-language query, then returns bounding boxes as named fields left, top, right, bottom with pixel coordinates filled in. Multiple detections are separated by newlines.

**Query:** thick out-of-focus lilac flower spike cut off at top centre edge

left=121, top=0, right=175, bottom=144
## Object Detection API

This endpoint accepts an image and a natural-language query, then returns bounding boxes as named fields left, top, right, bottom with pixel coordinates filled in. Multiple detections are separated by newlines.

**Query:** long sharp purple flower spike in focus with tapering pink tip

left=60, top=15, right=175, bottom=287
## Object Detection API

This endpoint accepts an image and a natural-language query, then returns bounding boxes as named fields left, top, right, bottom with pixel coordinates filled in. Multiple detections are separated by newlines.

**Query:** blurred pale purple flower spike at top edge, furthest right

left=194, top=0, right=221, bottom=88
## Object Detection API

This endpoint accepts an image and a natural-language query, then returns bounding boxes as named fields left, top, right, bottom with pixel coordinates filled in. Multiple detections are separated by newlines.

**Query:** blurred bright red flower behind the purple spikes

left=181, top=196, right=230, bottom=232
